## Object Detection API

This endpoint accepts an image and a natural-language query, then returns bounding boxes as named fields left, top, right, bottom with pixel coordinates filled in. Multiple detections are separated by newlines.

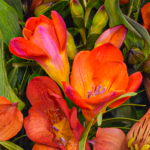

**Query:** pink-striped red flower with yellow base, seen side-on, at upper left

left=9, top=11, right=70, bottom=87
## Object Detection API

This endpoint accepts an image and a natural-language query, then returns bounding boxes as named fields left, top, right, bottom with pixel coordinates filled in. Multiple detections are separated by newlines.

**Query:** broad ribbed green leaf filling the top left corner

left=0, top=0, right=22, bottom=45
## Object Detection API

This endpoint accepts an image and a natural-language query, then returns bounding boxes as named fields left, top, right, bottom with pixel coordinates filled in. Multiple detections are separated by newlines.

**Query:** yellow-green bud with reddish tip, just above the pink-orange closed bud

left=89, top=5, right=108, bottom=34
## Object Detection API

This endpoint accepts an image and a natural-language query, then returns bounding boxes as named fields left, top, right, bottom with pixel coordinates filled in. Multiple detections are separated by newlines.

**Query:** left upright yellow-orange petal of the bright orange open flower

left=70, top=51, right=93, bottom=98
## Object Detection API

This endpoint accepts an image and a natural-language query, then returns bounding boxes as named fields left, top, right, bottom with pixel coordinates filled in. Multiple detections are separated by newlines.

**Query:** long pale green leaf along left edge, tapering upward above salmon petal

left=0, top=30, right=25, bottom=110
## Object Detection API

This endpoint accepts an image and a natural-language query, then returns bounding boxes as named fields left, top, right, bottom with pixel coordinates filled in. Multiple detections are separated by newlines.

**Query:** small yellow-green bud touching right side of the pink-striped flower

left=67, top=31, right=77, bottom=60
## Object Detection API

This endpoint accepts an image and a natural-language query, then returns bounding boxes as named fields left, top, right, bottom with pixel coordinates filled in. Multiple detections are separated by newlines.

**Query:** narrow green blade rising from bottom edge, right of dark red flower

left=79, top=119, right=94, bottom=150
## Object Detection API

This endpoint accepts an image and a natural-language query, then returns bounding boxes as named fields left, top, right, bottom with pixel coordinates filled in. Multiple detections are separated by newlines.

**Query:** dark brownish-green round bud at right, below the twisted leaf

left=128, top=47, right=145, bottom=64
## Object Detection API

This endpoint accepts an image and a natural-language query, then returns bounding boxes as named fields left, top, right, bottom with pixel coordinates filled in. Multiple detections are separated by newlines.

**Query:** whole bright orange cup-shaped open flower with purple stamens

left=63, top=43, right=142, bottom=121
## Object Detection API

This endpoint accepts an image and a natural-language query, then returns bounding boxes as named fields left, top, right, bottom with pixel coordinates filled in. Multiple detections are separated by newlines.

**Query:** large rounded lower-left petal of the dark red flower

left=24, top=101, right=65, bottom=150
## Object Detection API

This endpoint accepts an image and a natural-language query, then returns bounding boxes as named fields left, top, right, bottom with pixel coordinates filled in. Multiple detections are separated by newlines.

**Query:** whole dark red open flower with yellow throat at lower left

left=24, top=77, right=90, bottom=150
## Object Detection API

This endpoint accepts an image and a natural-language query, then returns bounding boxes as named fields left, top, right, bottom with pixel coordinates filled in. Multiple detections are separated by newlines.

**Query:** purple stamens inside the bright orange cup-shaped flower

left=87, top=84, right=106, bottom=98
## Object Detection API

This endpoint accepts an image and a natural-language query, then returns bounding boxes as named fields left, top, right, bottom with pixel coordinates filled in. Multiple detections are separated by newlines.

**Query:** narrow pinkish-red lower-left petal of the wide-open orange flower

left=62, top=82, right=90, bottom=110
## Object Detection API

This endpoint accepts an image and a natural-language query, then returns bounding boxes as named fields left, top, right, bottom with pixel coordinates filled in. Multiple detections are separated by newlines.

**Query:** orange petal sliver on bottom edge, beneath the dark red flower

left=32, top=143, right=60, bottom=150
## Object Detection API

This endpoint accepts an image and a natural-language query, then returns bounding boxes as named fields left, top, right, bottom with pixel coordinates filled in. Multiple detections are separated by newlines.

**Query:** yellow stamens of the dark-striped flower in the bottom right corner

left=128, top=137, right=150, bottom=150
